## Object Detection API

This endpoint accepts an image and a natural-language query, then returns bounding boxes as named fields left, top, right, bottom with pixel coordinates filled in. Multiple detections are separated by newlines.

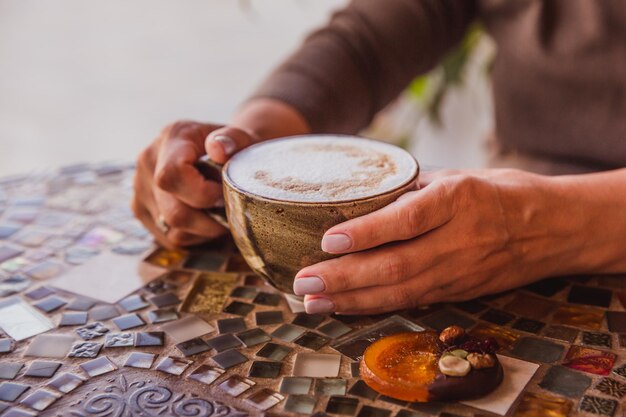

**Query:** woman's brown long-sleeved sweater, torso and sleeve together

left=255, top=0, right=626, bottom=169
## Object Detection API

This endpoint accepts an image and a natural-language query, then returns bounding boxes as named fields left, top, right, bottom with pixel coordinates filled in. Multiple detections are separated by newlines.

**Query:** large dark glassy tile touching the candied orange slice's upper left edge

left=332, top=316, right=424, bottom=361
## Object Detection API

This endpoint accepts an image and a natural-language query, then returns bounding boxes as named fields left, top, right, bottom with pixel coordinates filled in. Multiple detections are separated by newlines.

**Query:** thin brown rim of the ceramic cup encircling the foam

left=222, top=133, right=420, bottom=207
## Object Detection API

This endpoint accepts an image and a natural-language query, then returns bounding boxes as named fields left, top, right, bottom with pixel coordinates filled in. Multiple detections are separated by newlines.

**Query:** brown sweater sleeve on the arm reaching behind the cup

left=253, top=0, right=476, bottom=134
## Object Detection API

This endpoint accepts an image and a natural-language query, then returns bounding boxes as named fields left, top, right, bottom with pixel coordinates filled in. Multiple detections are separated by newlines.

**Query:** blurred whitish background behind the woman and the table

left=0, top=0, right=491, bottom=175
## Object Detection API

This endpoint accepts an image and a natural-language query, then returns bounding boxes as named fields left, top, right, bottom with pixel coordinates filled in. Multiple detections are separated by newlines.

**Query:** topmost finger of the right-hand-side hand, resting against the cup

left=322, top=183, right=455, bottom=253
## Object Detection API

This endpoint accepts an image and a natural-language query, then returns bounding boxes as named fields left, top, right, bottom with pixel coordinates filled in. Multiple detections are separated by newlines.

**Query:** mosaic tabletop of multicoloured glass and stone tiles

left=0, top=164, right=626, bottom=417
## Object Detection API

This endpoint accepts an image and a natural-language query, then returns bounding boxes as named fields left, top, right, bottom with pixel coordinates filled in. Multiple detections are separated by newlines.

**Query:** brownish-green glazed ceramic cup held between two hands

left=197, top=137, right=419, bottom=294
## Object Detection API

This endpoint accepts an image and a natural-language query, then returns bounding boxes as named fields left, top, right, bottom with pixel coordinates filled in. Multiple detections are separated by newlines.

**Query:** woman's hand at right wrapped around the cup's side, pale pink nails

left=294, top=170, right=559, bottom=314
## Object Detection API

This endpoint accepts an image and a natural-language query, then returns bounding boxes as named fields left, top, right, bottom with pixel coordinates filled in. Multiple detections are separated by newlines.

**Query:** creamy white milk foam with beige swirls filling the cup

left=226, top=135, right=417, bottom=202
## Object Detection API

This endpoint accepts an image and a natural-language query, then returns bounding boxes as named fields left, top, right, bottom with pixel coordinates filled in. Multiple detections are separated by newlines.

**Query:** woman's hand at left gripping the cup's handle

left=132, top=121, right=258, bottom=248
